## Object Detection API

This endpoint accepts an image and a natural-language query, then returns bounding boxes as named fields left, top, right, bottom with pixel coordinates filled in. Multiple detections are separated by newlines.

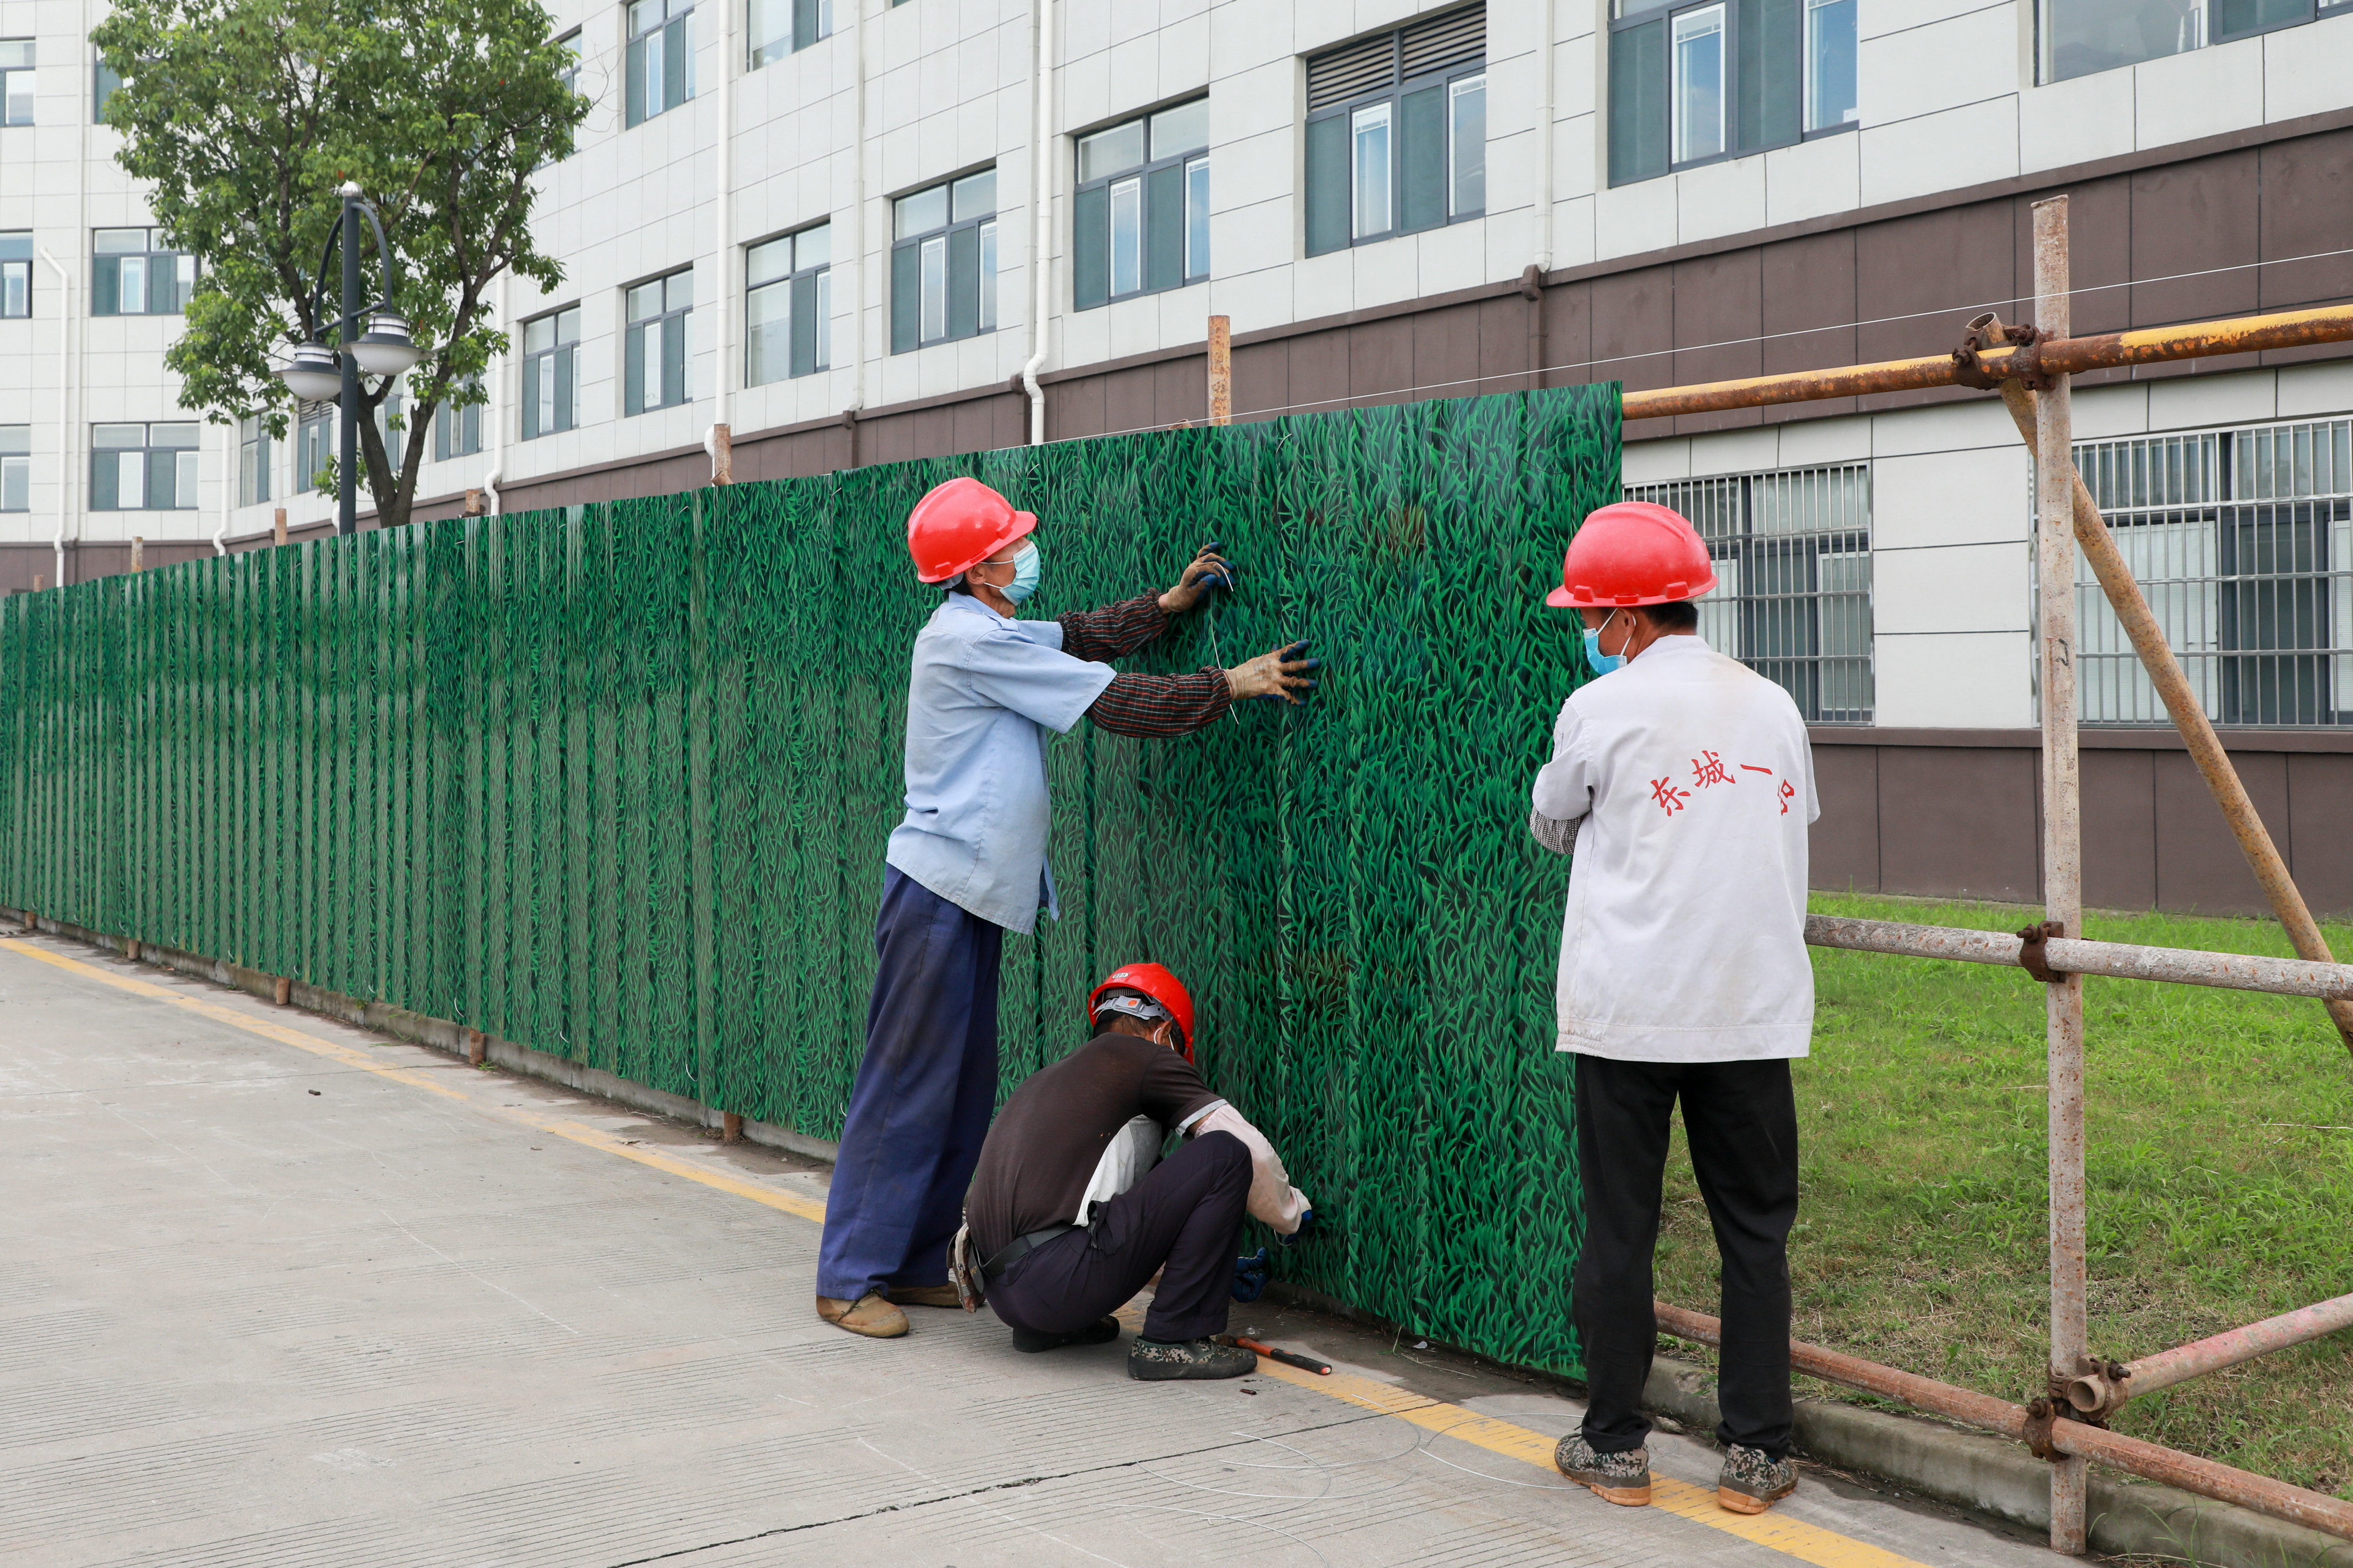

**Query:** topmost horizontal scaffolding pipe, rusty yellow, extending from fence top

left=1621, top=303, right=2353, bottom=419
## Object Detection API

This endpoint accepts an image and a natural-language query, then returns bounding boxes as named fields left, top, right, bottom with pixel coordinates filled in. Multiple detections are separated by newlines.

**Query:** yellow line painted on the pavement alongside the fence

left=0, top=942, right=1925, bottom=1568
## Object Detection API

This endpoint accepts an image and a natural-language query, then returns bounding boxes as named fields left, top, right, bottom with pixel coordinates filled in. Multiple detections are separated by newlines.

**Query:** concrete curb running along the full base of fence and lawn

left=0, top=909, right=2353, bottom=1568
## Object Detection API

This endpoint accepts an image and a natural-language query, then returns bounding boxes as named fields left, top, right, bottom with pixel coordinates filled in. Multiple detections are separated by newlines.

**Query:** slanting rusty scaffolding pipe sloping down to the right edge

left=1969, top=315, right=2353, bottom=1052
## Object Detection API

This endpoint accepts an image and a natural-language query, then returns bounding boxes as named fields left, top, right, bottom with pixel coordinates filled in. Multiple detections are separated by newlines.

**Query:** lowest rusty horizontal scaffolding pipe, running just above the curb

left=1654, top=1302, right=2353, bottom=1540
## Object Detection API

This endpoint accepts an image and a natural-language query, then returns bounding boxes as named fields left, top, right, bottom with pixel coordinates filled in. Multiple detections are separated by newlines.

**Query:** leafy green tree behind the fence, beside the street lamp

left=92, top=0, right=588, bottom=528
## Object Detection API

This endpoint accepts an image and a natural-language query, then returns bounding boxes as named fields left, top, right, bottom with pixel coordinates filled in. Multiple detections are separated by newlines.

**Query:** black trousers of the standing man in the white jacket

left=1574, top=1055, right=1798, bottom=1460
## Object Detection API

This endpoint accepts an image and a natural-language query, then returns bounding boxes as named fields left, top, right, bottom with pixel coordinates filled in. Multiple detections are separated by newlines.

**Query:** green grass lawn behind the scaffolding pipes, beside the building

left=1659, top=895, right=2353, bottom=1500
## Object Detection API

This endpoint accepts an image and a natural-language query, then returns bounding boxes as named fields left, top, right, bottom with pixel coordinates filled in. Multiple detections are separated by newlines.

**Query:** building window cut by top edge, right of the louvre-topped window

left=1609, top=0, right=1857, bottom=186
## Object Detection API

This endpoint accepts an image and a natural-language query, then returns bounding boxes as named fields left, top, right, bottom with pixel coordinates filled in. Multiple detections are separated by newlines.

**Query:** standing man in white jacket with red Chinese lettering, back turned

left=1529, top=502, right=1819, bottom=1514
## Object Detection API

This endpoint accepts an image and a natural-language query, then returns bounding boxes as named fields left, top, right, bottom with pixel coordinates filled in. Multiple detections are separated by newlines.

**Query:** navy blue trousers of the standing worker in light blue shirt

left=816, top=866, right=1005, bottom=1302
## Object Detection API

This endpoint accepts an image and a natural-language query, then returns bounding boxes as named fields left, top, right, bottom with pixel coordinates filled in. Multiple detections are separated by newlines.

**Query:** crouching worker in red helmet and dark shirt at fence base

left=958, top=963, right=1313, bottom=1380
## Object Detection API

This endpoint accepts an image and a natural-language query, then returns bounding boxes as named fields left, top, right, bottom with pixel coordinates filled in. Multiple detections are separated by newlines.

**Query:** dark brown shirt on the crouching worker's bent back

left=965, top=1033, right=1219, bottom=1257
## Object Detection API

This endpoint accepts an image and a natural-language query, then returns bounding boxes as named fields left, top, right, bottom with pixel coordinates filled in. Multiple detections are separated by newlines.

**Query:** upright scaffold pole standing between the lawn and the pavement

left=2035, top=195, right=2089, bottom=1554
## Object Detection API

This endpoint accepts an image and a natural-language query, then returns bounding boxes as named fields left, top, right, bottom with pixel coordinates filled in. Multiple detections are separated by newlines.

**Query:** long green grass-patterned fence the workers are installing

left=0, top=386, right=1619, bottom=1368
